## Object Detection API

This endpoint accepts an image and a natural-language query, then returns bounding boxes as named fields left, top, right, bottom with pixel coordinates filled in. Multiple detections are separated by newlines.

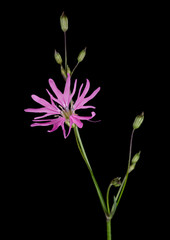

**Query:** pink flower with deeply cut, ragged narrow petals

left=25, top=74, right=100, bottom=138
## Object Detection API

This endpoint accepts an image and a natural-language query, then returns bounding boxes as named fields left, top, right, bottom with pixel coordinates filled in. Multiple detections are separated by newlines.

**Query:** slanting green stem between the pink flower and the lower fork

left=74, top=126, right=108, bottom=215
